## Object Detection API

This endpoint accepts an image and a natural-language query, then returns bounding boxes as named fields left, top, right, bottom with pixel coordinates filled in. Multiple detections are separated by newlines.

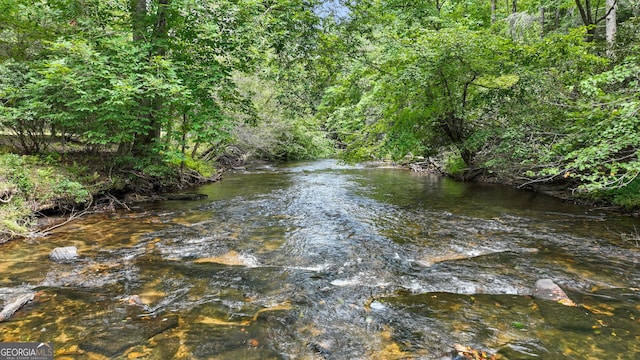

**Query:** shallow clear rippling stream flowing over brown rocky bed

left=0, top=160, right=640, bottom=359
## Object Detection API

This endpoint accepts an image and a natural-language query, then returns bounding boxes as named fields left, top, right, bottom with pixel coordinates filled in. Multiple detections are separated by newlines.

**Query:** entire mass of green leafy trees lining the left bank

left=0, top=0, right=336, bottom=170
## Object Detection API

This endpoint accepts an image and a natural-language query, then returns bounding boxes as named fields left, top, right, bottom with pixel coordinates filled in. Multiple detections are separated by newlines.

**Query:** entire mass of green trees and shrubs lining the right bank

left=317, top=0, right=640, bottom=208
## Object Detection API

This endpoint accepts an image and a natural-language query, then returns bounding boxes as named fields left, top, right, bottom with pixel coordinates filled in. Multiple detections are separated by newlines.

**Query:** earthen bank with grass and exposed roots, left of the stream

left=0, top=153, right=217, bottom=244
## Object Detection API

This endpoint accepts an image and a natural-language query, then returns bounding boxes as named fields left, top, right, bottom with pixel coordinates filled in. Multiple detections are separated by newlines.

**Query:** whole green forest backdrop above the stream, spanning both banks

left=0, top=0, right=640, bottom=208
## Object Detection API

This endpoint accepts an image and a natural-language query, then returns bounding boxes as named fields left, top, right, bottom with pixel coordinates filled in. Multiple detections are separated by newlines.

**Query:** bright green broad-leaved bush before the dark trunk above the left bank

left=0, top=38, right=182, bottom=153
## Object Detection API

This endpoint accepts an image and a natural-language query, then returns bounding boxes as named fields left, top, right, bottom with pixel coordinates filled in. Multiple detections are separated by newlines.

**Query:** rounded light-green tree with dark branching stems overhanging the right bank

left=320, top=24, right=519, bottom=164
